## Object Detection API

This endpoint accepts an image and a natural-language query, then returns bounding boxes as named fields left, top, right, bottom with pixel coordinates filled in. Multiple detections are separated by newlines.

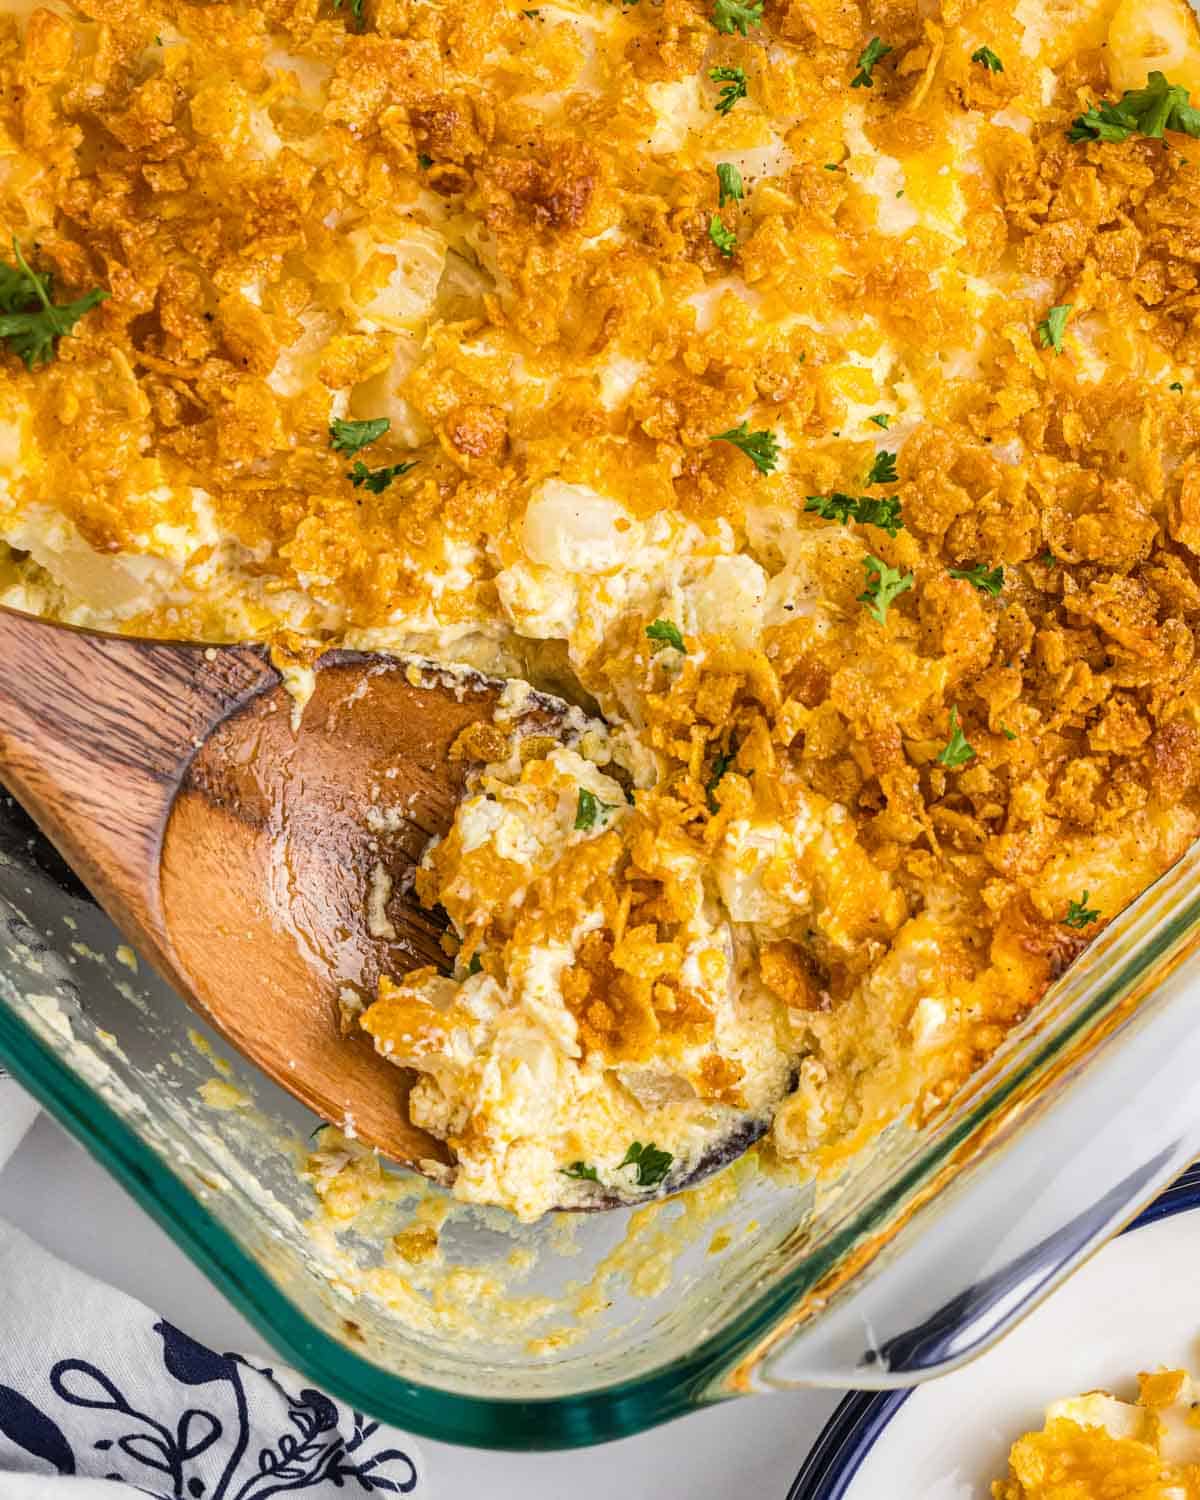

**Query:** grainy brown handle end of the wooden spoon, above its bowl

left=0, top=608, right=278, bottom=966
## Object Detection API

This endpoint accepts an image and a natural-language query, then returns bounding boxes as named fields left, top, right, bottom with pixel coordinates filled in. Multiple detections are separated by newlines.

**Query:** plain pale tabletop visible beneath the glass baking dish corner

left=0, top=1115, right=840, bottom=1500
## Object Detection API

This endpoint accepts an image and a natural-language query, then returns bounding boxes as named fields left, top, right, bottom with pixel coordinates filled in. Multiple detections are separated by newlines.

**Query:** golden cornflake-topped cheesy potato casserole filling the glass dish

left=0, top=0, right=1200, bottom=1218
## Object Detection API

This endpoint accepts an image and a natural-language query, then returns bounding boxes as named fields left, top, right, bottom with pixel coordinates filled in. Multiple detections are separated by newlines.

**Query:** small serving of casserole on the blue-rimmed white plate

left=992, top=1370, right=1200, bottom=1500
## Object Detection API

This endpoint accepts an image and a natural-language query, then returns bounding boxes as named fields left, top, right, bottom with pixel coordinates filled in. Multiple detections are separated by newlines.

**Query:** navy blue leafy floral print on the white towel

left=0, top=1322, right=417, bottom=1500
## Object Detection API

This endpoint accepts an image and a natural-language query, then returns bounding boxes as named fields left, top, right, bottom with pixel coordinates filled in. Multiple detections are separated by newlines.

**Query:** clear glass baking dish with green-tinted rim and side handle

left=0, top=795, right=1200, bottom=1449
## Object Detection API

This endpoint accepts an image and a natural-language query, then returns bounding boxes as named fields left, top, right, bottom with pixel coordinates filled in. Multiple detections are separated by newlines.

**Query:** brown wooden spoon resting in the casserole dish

left=0, top=609, right=767, bottom=1208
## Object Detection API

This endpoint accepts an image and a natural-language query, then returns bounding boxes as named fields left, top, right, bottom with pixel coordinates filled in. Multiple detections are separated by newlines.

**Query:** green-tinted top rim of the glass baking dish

left=0, top=864, right=1200, bottom=1451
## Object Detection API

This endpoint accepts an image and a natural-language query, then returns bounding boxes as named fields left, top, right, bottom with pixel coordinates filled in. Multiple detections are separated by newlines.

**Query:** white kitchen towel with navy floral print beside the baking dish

left=0, top=1220, right=429, bottom=1500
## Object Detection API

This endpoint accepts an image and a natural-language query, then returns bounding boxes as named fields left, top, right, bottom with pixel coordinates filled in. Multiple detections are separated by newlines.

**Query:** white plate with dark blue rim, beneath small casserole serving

left=789, top=1167, right=1200, bottom=1500
